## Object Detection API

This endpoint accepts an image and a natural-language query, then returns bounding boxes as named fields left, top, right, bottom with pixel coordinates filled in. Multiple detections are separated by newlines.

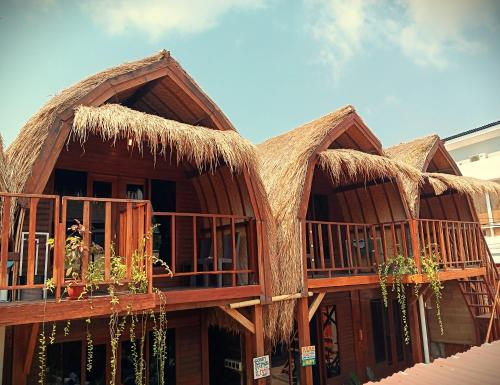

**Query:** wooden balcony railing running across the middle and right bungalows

left=303, top=219, right=488, bottom=278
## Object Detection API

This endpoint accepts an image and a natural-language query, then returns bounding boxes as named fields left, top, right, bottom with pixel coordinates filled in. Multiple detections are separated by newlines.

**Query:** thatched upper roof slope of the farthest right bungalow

left=384, top=134, right=440, bottom=172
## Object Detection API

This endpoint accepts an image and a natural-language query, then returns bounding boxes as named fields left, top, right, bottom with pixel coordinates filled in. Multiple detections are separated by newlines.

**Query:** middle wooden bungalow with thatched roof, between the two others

left=258, top=106, right=500, bottom=385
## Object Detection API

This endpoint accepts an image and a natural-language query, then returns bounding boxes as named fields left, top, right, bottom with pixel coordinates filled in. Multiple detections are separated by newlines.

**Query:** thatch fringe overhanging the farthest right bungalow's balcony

left=423, top=172, right=500, bottom=198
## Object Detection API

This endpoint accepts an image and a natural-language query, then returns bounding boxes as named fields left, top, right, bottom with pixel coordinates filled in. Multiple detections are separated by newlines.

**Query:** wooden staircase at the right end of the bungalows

left=458, top=239, right=500, bottom=344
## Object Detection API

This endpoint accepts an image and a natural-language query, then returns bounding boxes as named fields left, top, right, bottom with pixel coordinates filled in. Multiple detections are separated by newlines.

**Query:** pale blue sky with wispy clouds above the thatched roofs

left=0, top=0, right=500, bottom=146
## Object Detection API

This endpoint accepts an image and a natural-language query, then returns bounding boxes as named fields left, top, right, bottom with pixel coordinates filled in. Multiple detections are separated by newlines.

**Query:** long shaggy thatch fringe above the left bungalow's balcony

left=72, top=104, right=257, bottom=173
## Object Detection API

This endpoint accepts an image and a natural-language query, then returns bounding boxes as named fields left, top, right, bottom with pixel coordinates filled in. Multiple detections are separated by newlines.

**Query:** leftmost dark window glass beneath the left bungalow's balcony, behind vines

left=46, top=341, right=82, bottom=385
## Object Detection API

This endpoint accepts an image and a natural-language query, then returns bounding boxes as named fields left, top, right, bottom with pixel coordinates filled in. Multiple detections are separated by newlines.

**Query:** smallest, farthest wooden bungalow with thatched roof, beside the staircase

left=385, top=135, right=500, bottom=357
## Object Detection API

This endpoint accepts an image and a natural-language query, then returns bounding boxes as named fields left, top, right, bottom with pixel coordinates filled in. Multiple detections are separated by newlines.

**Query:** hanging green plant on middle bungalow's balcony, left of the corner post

left=378, top=255, right=419, bottom=344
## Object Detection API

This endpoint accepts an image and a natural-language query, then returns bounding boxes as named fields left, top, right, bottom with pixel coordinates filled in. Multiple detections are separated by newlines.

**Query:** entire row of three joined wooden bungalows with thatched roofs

left=0, top=51, right=500, bottom=385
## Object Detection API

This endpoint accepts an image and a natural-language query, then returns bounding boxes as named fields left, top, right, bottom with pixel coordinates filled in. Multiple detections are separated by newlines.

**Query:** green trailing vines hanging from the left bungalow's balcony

left=43, top=221, right=172, bottom=385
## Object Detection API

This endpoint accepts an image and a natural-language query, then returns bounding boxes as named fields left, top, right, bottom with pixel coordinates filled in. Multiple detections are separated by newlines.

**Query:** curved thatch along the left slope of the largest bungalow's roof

left=7, top=51, right=169, bottom=192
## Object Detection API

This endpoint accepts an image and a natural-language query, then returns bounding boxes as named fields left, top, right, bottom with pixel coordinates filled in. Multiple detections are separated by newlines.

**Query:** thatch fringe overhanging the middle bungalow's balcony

left=318, top=149, right=422, bottom=185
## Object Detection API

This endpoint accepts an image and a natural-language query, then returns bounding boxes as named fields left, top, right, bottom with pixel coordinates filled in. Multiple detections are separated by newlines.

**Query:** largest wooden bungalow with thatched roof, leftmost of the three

left=0, top=51, right=274, bottom=385
